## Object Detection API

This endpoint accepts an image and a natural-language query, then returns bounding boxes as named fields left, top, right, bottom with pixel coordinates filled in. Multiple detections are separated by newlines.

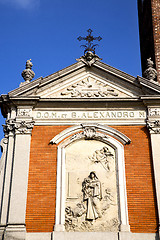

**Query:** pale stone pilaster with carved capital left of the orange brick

left=4, top=119, right=34, bottom=240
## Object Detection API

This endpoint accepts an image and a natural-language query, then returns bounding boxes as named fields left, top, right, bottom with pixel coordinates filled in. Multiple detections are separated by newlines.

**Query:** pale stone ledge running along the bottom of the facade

left=0, top=230, right=159, bottom=240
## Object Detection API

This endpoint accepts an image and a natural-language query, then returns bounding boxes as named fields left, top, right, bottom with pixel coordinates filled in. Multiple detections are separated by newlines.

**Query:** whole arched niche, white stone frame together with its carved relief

left=51, top=124, right=130, bottom=232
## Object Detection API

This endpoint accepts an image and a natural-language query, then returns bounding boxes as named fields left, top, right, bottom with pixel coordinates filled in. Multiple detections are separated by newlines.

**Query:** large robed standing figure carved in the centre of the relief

left=82, top=172, right=102, bottom=220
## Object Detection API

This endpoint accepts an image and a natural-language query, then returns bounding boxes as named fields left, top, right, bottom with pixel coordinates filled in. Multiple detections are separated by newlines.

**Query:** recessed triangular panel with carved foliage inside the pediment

left=38, top=74, right=134, bottom=99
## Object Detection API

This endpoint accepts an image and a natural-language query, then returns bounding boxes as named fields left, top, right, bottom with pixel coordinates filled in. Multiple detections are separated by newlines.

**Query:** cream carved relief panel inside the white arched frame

left=65, top=139, right=120, bottom=232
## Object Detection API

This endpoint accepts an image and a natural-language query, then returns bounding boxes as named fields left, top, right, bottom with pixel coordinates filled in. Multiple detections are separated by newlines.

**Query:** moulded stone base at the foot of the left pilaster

left=3, top=224, right=26, bottom=240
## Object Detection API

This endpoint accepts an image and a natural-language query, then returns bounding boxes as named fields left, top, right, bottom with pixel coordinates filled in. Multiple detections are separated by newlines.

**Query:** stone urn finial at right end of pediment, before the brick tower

left=143, top=58, right=157, bottom=80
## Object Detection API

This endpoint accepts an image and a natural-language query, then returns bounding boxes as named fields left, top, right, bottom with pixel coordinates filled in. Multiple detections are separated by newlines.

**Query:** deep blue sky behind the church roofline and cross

left=0, top=0, right=141, bottom=141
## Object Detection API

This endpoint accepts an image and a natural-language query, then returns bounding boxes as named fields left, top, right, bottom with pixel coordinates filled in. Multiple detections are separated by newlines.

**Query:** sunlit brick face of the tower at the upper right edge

left=151, top=0, right=160, bottom=82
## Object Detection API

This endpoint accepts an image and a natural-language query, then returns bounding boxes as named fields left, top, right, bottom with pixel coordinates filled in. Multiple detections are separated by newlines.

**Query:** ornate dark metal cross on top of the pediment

left=77, top=29, right=102, bottom=54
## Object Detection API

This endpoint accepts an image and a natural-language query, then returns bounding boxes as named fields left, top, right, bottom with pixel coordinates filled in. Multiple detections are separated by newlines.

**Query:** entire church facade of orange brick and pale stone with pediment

left=0, top=3, right=160, bottom=240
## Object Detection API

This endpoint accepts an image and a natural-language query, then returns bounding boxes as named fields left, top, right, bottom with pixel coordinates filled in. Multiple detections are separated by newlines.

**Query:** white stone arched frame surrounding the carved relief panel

left=50, top=124, right=130, bottom=231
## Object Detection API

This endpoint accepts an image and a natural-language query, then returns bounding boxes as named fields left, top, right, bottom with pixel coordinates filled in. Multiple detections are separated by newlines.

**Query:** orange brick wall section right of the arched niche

left=114, top=126, right=158, bottom=233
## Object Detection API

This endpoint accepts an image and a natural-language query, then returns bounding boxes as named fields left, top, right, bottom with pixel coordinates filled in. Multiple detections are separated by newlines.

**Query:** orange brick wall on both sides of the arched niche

left=26, top=126, right=158, bottom=232
